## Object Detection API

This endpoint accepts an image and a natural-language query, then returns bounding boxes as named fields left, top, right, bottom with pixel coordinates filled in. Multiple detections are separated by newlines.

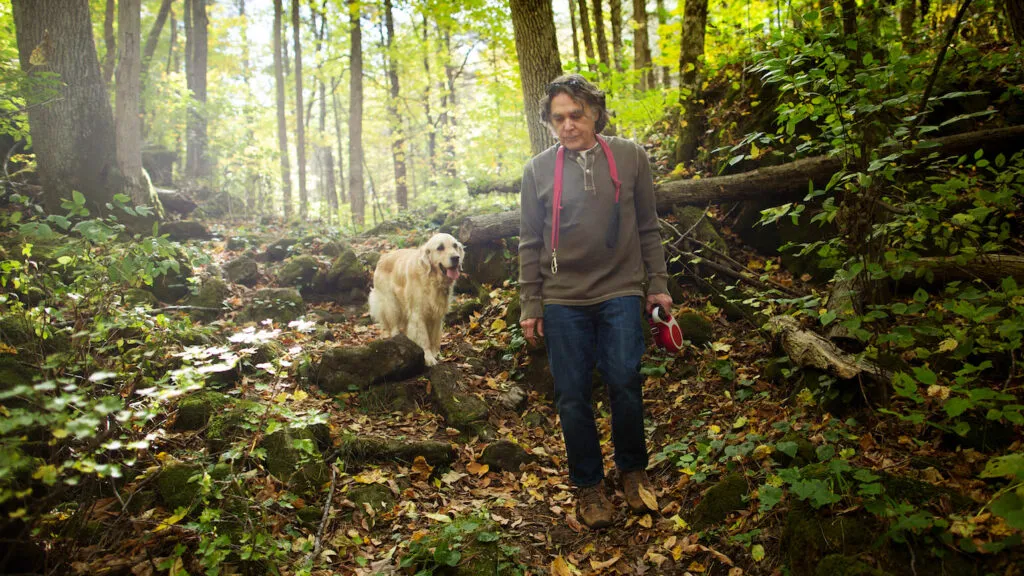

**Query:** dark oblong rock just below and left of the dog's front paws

left=310, top=334, right=425, bottom=394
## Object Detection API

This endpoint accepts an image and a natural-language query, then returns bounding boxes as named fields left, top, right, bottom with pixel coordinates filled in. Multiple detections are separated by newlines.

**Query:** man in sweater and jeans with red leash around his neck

left=519, top=74, right=672, bottom=528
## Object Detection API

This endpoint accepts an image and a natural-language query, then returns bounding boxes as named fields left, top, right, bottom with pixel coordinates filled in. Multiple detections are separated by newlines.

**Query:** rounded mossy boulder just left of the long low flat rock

left=261, top=427, right=331, bottom=494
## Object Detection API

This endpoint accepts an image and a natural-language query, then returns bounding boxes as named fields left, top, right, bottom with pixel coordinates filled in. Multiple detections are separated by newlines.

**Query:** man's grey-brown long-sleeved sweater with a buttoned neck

left=519, top=136, right=668, bottom=319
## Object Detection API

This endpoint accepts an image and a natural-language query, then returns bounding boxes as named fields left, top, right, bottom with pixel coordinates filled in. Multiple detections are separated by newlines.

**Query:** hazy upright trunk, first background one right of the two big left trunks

left=185, top=0, right=211, bottom=183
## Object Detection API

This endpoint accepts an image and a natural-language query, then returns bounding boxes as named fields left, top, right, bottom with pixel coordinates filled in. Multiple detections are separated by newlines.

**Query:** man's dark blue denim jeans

left=544, top=296, right=647, bottom=488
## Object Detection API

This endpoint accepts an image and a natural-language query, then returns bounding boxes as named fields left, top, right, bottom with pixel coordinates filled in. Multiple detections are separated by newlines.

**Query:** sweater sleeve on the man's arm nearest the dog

left=519, top=161, right=548, bottom=320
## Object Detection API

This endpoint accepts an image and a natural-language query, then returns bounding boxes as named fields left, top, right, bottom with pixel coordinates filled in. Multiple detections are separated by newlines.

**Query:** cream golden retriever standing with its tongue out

left=370, top=234, right=465, bottom=366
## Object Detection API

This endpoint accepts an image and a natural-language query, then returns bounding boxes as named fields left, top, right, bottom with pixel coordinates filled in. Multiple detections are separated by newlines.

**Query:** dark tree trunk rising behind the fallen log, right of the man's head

left=676, top=0, right=708, bottom=165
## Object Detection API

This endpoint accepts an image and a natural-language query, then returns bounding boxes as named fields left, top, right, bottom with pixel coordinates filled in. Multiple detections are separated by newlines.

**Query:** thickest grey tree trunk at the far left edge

left=12, top=0, right=123, bottom=214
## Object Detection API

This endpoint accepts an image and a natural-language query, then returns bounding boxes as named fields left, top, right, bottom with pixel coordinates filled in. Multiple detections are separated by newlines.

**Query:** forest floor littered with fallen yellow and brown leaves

left=34, top=216, right=1019, bottom=576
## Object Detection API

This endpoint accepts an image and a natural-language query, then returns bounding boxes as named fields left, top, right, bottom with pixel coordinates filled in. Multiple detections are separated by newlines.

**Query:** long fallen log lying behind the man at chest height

left=459, top=126, right=1024, bottom=244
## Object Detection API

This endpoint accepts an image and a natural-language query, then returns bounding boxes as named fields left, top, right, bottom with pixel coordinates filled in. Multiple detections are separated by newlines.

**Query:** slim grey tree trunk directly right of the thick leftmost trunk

left=114, top=0, right=152, bottom=206
